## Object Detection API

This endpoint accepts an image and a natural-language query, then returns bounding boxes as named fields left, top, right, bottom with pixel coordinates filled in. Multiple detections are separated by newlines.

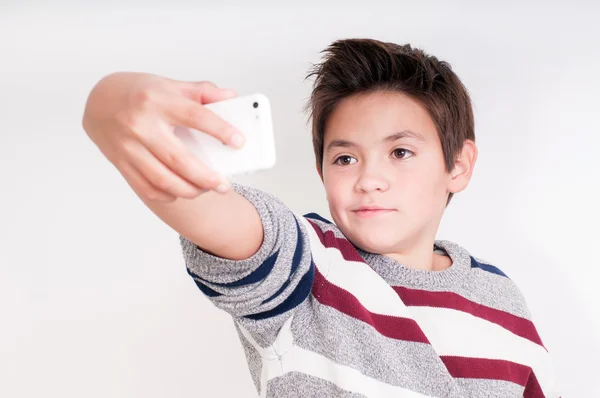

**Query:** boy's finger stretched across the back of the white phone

left=164, top=95, right=244, bottom=148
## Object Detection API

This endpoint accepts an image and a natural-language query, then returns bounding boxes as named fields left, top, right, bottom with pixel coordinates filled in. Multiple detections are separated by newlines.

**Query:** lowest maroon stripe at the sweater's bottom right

left=440, top=356, right=544, bottom=398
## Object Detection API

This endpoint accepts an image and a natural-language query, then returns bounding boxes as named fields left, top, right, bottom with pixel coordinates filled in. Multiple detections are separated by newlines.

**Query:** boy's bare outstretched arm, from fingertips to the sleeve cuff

left=83, top=73, right=263, bottom=259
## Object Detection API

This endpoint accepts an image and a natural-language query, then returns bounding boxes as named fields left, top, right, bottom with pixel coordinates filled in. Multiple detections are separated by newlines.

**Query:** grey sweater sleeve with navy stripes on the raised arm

left=180, top=183, right=314, bottom=323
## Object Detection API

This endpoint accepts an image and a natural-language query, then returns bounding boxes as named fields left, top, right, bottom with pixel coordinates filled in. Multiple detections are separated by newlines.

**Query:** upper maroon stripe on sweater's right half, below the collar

left=393, top=286, right=545, bottom=348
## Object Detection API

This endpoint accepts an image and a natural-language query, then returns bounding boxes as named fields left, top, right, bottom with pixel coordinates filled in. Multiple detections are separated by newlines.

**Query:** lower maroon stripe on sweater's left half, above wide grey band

left=312, top=267, right=429, bottom=344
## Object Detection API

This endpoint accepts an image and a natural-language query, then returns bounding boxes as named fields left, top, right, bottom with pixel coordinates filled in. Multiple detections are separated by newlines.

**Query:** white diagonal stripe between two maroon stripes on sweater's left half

left=302, top=218, right=412, bottom=318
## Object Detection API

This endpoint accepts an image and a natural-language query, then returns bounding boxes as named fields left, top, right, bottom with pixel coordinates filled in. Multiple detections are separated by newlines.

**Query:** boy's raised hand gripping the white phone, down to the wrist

left=82, top=72, right=244, bottom=202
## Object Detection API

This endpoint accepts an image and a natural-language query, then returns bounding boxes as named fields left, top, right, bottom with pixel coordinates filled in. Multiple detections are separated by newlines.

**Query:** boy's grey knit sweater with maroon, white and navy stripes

left=180, top=184, right=558, bottom=398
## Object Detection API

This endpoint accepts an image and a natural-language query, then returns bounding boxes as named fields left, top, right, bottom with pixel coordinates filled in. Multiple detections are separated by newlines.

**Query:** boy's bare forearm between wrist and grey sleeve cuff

left=142, top=189, right=263, bottom=260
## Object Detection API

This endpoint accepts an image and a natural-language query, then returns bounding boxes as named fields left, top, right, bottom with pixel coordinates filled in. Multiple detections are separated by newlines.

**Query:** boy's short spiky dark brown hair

left=305, top=39, right=475, bottom=204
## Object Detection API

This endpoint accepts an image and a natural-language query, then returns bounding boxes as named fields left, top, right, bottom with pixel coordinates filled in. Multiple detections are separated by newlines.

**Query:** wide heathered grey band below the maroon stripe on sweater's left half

left=292, top=297, right=461, bottom=397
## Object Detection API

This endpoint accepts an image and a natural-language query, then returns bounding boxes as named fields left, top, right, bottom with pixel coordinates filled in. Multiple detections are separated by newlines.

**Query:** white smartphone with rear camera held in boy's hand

left=175, top=93, right=276, bottom=176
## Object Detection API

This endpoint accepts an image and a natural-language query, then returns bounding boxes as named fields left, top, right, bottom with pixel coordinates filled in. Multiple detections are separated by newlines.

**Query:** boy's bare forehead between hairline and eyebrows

left=324, top=92, right=437, bottom=144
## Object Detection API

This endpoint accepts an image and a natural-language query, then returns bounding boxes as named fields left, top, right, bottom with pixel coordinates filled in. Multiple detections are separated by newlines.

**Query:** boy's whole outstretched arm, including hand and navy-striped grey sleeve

left=83, top=73, right=314, bottom=332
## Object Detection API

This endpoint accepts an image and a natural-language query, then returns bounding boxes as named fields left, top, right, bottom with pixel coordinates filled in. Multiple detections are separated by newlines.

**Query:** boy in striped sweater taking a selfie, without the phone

left=83, top=39, right=558, bottom=398
